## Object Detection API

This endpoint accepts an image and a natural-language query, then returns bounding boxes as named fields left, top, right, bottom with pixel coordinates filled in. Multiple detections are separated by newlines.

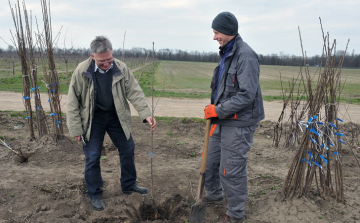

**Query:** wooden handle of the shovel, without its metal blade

left=196, top=119, right=211, bottom=202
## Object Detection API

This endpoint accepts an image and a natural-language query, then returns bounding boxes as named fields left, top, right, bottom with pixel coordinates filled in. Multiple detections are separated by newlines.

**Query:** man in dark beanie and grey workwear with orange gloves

left=204, top=12, right=265, bottom=223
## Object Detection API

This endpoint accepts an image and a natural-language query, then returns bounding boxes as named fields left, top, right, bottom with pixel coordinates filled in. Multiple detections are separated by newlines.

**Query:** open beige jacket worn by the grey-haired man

left=66, top=57, right=151, bottom=141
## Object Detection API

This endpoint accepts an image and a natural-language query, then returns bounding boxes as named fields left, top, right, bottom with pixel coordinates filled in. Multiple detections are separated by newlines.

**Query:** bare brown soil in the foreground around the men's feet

left=0, top=112, right=360, bottom=223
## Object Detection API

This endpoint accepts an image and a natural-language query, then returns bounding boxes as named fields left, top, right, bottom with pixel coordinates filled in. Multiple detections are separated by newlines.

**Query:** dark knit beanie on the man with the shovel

left=211, top=12, right=239, bottom=36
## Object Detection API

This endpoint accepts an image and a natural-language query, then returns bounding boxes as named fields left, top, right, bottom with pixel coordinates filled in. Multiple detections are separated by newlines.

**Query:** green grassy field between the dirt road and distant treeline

left=0, top=58, right=360, bottom=104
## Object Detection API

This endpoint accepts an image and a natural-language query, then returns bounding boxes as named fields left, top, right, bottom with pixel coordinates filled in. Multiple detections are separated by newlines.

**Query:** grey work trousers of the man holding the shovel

left=205, top=124, right=257, bottom=219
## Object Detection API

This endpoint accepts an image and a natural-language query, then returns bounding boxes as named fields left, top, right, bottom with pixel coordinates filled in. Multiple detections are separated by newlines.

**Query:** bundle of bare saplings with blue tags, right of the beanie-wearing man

left=274, top=19, right=356, bottom=203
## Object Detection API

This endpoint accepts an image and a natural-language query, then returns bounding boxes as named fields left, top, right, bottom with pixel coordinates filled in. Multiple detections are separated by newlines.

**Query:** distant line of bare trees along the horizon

left=0, top=46, right=360, bottom=68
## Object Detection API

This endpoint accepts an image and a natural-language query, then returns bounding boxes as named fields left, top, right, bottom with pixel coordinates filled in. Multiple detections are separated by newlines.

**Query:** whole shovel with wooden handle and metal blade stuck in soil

left=189, top=119, right=211, bottom=223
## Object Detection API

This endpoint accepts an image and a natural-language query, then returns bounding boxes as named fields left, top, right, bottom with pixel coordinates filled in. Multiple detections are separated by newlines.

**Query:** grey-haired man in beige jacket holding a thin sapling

left=66, top=36, right=156, bottom=211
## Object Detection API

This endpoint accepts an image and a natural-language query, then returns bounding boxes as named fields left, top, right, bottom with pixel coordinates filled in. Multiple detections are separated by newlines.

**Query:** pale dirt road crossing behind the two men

left=0, top=91, right=360, bottom=123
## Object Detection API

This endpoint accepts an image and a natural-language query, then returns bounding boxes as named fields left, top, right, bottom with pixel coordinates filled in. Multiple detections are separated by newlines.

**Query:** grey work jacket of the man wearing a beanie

left=211, top=34, right=265, bottom=127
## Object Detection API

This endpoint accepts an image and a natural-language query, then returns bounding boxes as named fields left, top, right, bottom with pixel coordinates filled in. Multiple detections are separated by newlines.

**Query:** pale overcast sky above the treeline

left=0, top=0, right=360, bottom=56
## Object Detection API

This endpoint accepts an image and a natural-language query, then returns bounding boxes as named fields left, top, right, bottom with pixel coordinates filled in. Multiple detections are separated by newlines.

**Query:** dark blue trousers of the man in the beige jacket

left=83, top=111, right=136, bottom=199
